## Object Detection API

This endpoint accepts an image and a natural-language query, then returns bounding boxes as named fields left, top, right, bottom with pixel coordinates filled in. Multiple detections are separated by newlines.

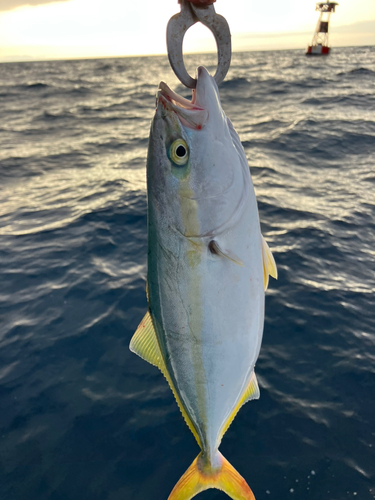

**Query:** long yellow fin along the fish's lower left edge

left=129, top=311, right=201, bottom=447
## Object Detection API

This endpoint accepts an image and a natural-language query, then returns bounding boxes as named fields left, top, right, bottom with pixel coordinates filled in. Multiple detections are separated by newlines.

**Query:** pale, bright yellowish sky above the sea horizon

left=0, top=0, right=375, bottom=62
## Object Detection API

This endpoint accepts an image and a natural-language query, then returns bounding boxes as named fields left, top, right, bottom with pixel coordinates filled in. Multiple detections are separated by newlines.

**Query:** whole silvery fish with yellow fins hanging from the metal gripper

left=130, top=66, right=277, bottom=500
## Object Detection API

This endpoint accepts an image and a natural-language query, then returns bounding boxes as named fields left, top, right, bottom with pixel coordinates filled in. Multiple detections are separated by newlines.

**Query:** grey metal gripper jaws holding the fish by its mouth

left=167, top=0, right=232, bottom=89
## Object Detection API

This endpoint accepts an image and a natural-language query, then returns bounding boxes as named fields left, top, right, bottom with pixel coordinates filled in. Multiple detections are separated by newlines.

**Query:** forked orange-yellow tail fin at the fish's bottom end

left=168, top=451, right=255, bottom=500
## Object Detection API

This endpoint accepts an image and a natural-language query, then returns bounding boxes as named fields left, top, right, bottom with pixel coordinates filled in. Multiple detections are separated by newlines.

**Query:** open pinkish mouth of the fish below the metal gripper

left=157, top=82, right=208, bottom=130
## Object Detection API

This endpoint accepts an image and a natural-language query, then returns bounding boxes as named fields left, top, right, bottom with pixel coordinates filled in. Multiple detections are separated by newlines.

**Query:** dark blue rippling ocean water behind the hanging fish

left=0, top=47, right=375, bottom=500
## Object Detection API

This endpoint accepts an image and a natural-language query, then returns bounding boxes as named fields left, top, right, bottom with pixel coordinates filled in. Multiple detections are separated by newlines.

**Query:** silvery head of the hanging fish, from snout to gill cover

left=147, top=67, right=249, bottom=237
